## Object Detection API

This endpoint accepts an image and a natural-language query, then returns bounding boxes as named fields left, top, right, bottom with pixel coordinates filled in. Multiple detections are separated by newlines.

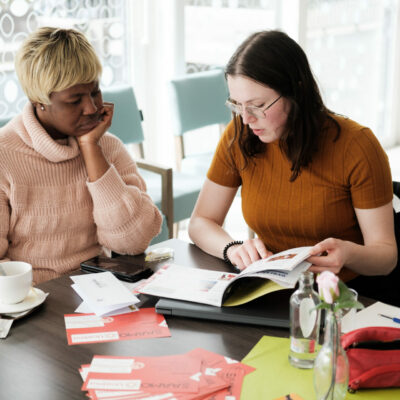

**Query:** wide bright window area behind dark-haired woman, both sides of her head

left=182, top=0, right=400, bottom=147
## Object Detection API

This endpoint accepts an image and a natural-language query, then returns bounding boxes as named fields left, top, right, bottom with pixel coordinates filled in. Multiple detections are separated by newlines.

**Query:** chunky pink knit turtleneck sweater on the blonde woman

left=0, top=104, right=161, bottom=283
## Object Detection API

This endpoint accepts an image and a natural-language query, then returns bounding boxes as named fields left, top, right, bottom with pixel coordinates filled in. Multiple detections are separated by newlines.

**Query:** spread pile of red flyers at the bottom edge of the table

left=79, top=348, right=254, bottom=400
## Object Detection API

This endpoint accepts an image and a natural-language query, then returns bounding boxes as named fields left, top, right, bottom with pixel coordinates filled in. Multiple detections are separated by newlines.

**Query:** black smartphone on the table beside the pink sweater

left=81, top=256, right=153, bottom=282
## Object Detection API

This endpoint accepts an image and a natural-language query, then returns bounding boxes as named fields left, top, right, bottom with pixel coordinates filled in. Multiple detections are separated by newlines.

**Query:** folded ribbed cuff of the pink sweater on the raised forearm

left=86, top=165, right=131, bottom=208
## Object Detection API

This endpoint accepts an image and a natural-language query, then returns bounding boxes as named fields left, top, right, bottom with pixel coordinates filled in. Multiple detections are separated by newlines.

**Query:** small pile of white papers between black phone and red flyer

left=71, top=272, right=139, bottom=316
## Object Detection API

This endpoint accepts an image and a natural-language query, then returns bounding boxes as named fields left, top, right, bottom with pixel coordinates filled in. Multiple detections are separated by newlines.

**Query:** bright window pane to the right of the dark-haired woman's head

left=305, top=0, right=400, bottom=145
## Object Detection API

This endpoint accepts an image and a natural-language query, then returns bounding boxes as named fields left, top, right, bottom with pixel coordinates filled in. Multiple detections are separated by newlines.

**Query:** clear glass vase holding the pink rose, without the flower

left=314, top=310, right=349, bottom=400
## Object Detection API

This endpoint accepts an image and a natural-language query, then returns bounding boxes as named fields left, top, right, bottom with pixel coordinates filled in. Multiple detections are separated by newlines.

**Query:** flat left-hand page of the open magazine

left=137, top=264, right=238, bottom=307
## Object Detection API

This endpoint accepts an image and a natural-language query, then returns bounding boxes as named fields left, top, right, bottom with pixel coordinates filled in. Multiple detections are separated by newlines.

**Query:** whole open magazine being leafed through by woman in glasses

left=137, top=247, right=311, bottom=307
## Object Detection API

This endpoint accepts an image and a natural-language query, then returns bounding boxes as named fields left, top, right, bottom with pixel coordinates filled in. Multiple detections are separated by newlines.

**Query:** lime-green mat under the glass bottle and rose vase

left=240, top=336, right=400, bottom=400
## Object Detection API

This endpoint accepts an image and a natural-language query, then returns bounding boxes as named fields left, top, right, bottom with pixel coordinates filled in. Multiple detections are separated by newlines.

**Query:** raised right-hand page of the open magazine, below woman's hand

left=239, top=246, right=311, bottom=276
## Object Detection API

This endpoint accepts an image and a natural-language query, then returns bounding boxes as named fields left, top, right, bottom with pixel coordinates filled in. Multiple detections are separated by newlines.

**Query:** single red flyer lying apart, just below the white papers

left=64, top=307, right=171, bottom=345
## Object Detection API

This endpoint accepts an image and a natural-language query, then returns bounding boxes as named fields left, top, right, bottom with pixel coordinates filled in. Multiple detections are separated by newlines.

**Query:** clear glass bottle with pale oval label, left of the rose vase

left=289, top=271, right=321, bottom=368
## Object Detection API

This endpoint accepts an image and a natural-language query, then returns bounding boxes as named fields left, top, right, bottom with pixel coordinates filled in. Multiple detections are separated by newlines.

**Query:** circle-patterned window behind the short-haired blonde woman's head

left=0, top=0, right=130, bottom=117
